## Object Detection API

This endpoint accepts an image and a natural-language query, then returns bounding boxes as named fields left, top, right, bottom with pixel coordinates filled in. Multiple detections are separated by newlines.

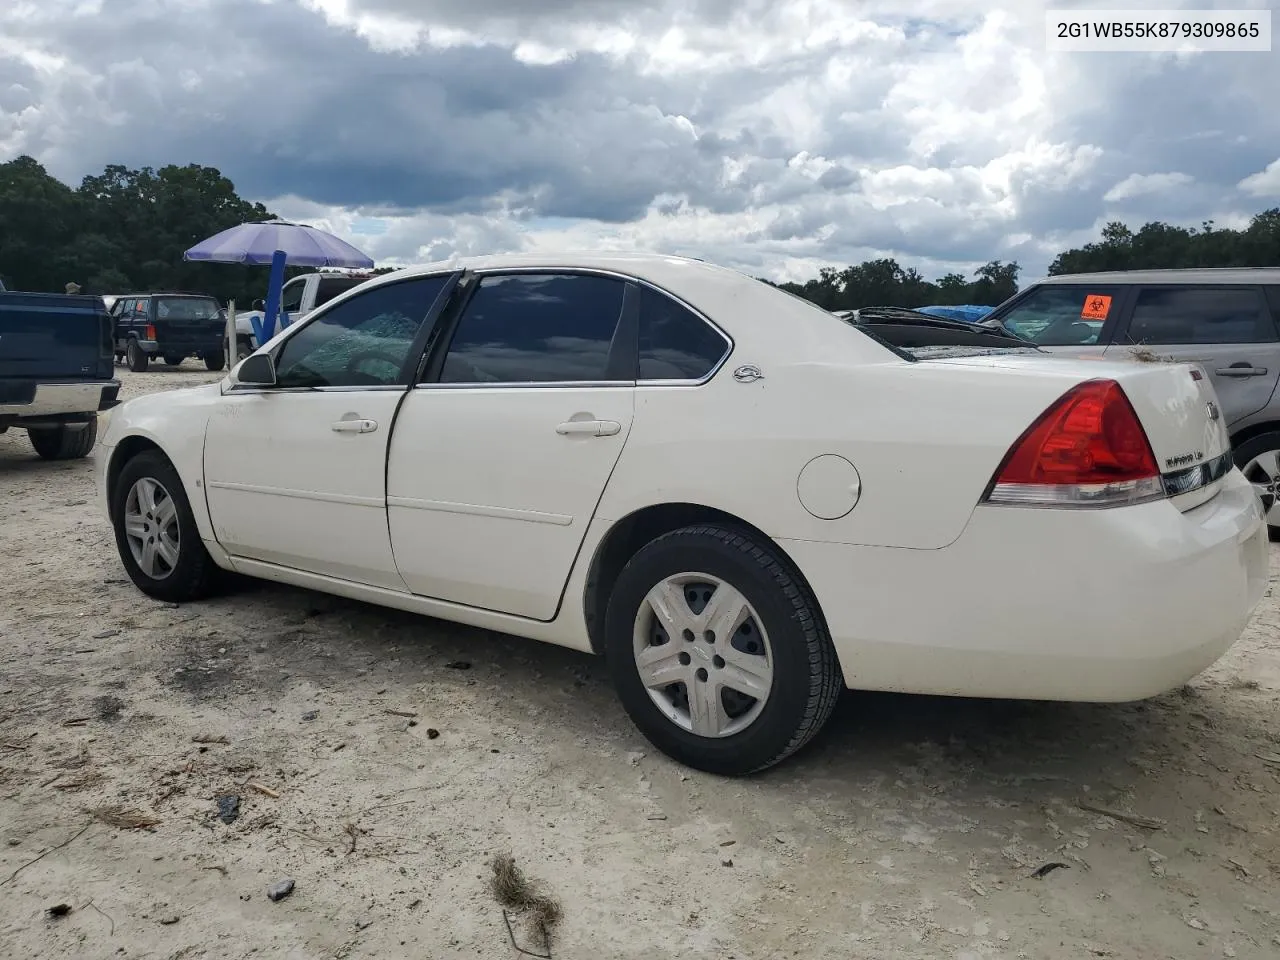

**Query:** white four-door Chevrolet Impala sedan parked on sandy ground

left=97, top=255, right=1267, bottom=774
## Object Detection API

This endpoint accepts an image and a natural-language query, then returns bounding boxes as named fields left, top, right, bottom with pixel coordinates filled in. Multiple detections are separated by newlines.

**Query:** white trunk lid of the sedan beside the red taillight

left=922, top=351, right=1231, bottom=511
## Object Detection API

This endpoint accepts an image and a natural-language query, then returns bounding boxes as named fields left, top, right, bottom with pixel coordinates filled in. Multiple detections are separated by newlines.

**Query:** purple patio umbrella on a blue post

left=183, top=220, right=374, bottom=343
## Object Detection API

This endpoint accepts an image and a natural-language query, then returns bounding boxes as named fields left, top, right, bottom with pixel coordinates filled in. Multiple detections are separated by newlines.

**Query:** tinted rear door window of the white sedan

left=440, top=274, right=626, bottom=383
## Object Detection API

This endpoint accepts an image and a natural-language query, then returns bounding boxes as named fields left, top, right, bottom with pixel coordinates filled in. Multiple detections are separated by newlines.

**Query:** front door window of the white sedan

left=275, top=276, right=448, bottom=387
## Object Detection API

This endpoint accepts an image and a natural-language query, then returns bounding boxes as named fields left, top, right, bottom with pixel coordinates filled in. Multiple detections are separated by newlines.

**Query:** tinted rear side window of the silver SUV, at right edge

left=1129, top=287, right=1276, bottom=344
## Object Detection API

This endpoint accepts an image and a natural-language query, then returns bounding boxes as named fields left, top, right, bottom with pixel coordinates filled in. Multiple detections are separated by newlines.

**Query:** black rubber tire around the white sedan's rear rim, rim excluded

left=604, top=526, right=844, bottom=776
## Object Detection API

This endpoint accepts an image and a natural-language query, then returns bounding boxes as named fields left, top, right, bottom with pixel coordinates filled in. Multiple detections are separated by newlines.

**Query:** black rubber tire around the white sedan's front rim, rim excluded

left=111, top=449, right=219, bottom=603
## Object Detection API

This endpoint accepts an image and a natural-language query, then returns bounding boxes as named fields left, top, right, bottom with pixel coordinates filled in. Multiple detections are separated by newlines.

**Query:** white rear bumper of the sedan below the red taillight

left=778, top=470, right=1268, bottom=701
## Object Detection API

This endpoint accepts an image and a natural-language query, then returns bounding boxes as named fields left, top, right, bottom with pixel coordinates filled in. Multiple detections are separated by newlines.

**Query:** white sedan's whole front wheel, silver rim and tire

left=111, top=451, right=218, bottom=603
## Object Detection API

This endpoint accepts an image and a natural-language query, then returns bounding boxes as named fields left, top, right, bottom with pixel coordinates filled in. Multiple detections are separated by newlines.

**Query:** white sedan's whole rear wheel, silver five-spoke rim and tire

left=605, top=526, right=844, bottom=776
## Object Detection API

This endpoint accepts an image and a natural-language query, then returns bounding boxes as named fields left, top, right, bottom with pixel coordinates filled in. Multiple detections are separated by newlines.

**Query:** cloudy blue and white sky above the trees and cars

left=0, top=0, right=1280, bottom=282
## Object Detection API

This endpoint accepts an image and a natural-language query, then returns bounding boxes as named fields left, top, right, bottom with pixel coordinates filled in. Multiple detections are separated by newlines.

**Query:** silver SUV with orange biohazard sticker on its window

left=982, top=268, right=1280, bottom=539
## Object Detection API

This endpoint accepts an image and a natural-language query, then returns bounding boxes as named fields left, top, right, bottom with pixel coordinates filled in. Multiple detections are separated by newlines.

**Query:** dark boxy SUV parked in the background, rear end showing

left=111, top=293, right=227, bottom=372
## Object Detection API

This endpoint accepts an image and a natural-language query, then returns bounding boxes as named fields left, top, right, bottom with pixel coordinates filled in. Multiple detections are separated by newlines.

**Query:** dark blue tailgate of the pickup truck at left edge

left=0, top=292, right=113, bottom=381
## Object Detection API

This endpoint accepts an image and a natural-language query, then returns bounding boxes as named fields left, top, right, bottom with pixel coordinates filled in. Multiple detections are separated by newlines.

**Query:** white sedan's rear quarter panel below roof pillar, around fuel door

left=598, top=352, right=1082, bottom=549
